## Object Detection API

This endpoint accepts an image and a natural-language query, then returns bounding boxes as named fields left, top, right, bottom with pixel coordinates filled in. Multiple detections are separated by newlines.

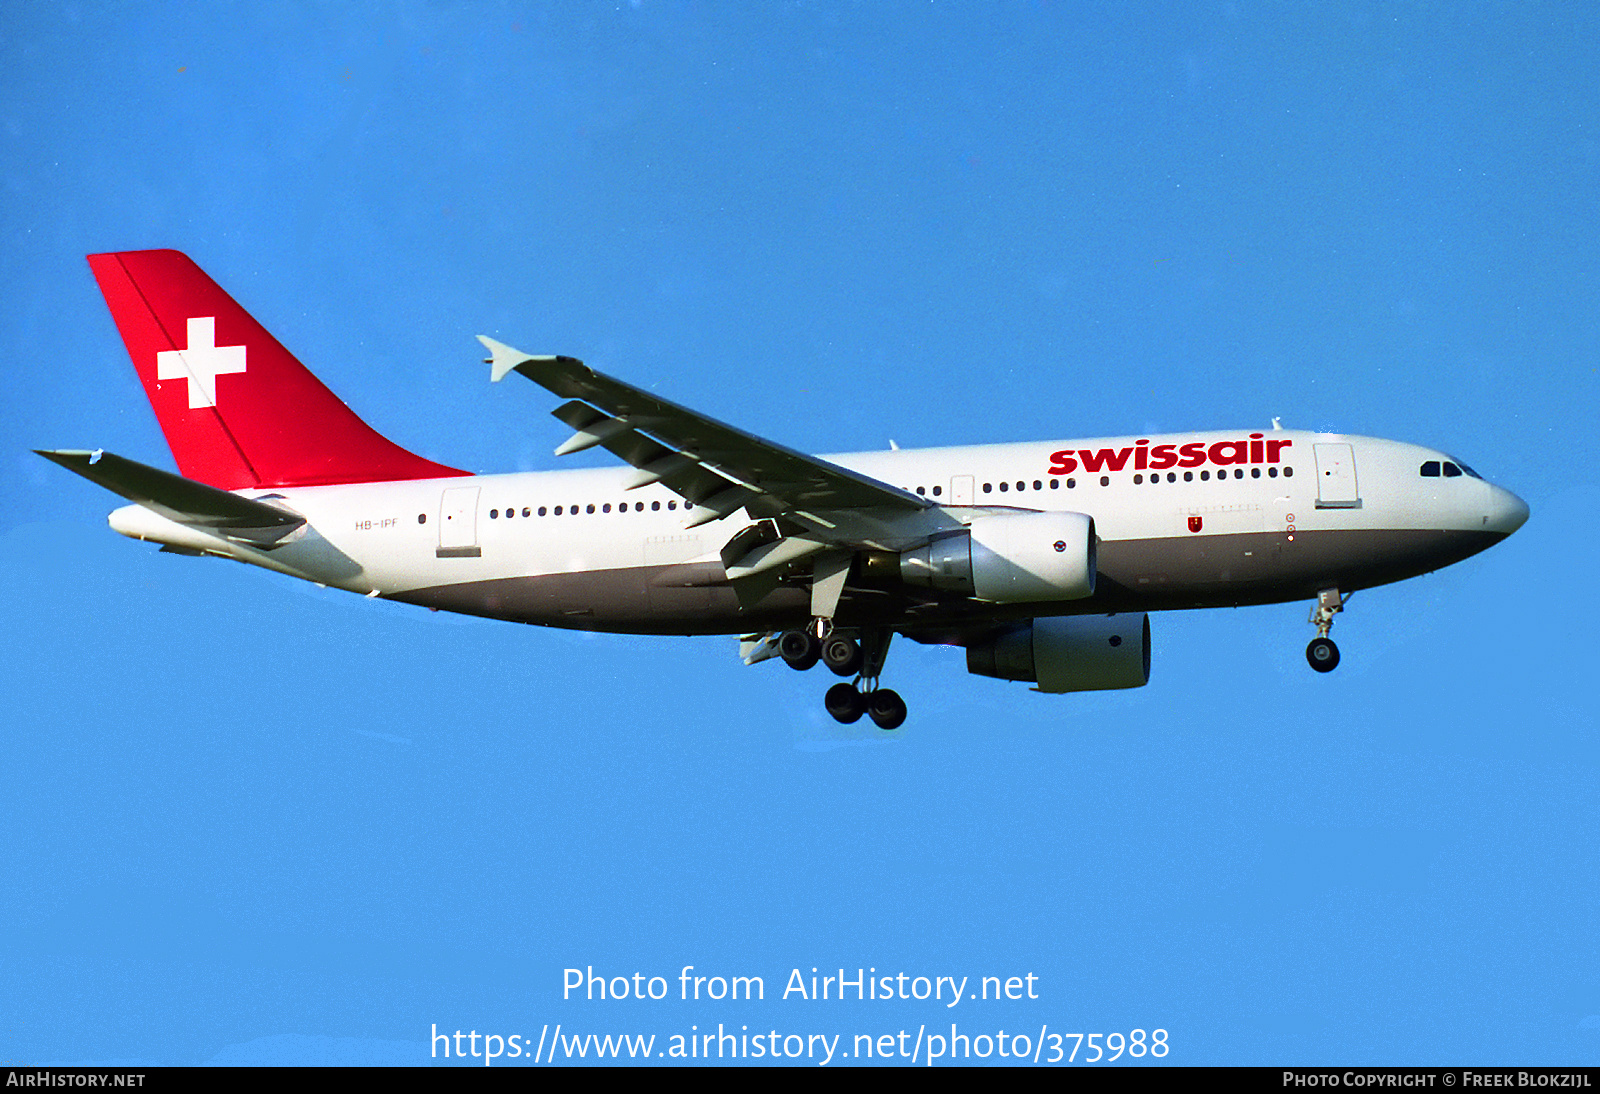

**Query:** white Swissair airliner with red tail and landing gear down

left=35, top=250, right=1528, bottom=729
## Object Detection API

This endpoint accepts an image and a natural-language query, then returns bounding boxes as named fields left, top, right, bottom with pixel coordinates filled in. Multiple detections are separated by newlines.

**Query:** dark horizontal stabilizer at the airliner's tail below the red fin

left=34, top=448, right=306, bottom=547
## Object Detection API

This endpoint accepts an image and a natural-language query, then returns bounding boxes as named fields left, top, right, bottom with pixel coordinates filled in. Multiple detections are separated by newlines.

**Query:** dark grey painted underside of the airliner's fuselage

left=389, top=529, right=1504, bottom=641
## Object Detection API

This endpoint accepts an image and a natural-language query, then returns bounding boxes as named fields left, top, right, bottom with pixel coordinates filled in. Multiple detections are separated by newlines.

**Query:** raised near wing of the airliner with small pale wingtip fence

left=478, top=334, right=931, bottom=528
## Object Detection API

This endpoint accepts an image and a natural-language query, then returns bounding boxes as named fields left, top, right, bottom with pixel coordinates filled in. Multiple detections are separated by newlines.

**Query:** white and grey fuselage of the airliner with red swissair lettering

left=112, top=430, right=1526, bottom=633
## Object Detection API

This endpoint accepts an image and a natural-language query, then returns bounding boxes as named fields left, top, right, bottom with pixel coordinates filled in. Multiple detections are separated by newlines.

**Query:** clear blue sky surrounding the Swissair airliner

left=0, top=0, right=1600, bottom=1064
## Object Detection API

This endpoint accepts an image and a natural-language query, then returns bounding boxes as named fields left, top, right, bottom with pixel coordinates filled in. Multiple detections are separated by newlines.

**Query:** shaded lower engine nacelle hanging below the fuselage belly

left=966, top=611, right=1150, bottom=693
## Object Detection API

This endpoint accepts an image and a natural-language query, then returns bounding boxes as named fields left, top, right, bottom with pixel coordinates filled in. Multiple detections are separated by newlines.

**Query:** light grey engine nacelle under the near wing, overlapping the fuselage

left=899, top=513, right=1096, bottom=605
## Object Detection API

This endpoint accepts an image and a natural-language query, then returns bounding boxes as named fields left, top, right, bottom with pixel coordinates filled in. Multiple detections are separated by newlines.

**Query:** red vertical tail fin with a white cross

left=90, top=251, right=467, bottom=489
